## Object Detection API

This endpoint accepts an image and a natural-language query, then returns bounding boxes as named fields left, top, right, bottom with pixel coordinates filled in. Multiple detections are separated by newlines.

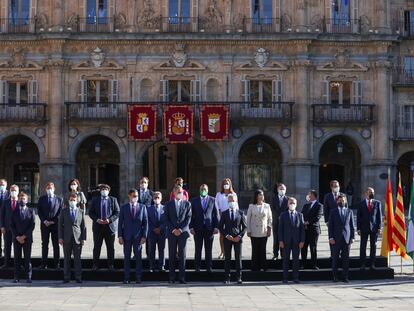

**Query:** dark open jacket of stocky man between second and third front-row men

left=89, top=195, right=119, bottom=233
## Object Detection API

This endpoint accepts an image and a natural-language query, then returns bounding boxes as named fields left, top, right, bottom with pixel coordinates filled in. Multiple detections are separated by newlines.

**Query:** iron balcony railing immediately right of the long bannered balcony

left=312, top=104, right=375, bottom=125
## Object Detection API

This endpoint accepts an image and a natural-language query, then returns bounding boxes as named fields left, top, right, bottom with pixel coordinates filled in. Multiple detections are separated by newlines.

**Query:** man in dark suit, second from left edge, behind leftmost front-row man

left=0, top=185, right=19, bottom=268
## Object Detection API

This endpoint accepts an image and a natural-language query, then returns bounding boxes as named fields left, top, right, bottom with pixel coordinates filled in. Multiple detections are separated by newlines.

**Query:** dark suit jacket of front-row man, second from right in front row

left=278, top=211, right=305, bottom=247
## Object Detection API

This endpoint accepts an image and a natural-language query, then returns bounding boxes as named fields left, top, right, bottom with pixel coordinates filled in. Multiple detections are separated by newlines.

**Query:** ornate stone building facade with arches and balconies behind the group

left=0, top=0, right=414, bottom=210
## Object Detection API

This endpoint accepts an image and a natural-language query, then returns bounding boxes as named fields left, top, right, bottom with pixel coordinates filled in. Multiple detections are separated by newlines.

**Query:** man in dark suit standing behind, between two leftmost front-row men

left=37, top=182, right=63, bottom=269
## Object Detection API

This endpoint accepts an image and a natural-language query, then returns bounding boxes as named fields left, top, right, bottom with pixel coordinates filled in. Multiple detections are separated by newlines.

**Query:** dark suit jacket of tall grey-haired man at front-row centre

left=164, top=200, right=191, bottom=238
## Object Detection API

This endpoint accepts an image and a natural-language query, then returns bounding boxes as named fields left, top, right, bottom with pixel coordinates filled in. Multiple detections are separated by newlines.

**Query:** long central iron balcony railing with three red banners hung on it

left=65, top=102, right=294, bottom=122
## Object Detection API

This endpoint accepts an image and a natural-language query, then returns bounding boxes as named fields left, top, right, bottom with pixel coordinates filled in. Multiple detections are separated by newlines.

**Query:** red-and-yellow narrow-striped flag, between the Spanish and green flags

left=393, top=174, right=408, bottom=259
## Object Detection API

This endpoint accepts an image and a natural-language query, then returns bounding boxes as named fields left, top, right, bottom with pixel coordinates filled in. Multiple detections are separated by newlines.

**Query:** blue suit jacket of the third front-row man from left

left=118, top=203, right=148, bottom=241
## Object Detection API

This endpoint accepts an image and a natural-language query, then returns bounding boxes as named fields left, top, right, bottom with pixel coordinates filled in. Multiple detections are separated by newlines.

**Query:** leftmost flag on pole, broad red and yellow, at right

left=381, top=173, right=394, bottom=257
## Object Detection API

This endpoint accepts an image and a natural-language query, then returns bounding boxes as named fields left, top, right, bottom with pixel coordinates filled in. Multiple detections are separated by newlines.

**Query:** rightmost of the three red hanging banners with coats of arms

left=200, top=105, right=229, bottom=141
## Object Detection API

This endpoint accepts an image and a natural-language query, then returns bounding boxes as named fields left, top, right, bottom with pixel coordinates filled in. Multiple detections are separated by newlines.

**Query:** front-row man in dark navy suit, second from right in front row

left=278, top=198, right=305, bottom=283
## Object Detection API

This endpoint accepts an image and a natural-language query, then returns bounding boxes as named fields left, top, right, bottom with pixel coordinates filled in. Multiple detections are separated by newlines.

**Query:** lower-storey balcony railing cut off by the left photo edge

left=0, top=103, right=47, bottom=122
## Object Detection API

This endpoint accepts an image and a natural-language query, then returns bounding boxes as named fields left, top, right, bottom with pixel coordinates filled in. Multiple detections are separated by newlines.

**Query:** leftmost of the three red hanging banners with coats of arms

left=128, top=105, right=157, bottom=141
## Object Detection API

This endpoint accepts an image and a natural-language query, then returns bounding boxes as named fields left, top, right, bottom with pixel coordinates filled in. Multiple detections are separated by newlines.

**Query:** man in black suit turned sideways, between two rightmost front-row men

left=301, top=190, right=323, bottom=270
